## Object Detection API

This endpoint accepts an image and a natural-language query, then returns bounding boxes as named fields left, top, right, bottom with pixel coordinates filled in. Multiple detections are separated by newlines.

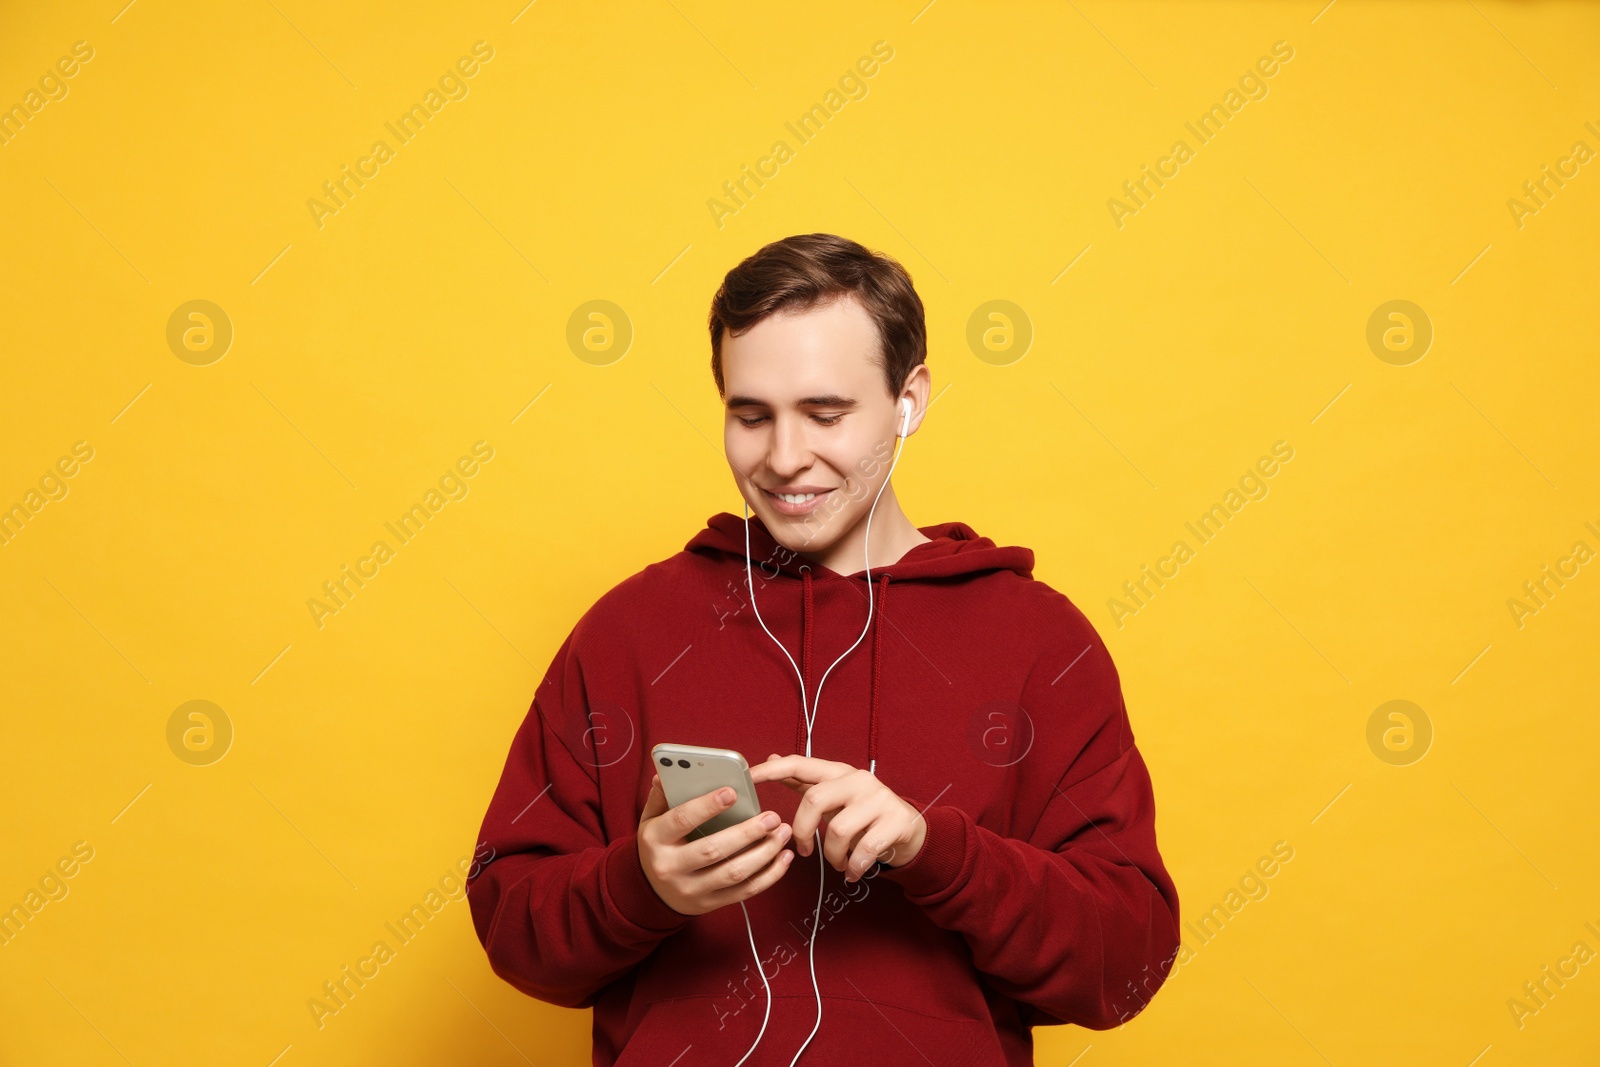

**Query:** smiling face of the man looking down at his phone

left=722, top=296, right=926, bottom=553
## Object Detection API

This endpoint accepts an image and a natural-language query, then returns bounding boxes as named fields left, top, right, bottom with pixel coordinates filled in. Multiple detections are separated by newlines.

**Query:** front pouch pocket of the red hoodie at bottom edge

left=614, top=995, right=1006, bottom=1067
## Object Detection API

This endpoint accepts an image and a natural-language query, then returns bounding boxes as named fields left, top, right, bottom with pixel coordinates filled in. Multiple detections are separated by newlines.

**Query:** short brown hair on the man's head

left=709, top=234, right=928, bottom=397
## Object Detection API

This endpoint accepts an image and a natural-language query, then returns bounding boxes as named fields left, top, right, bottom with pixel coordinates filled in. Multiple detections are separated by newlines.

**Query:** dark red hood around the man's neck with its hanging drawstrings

left=685, top=512, right=1034, bottom=774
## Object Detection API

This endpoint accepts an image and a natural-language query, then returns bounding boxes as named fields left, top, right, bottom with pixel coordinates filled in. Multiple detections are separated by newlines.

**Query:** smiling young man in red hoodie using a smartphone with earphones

left=469, top=234, right=1179, bottom=1067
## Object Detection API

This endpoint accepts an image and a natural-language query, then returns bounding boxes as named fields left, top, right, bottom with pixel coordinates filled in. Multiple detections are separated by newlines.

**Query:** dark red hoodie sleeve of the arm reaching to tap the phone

left=878, top=627, right=1179, bottom=1030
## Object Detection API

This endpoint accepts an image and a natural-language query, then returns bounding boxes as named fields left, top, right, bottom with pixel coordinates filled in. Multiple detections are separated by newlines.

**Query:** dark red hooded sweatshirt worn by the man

left=469, top=512, right=1179, bottom=1067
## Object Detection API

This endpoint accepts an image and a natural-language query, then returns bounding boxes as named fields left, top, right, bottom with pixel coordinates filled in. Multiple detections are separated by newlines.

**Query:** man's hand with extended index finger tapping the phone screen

left=750, top=752, right=928, bottom=881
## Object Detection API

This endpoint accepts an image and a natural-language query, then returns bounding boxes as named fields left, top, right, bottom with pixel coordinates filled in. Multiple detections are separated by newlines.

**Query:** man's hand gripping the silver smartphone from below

left=638, top=774, right=794, bottom=915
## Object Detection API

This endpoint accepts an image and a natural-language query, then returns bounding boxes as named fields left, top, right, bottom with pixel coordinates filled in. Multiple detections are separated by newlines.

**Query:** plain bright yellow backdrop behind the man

left=0, top=0, right=1600, bottom=1067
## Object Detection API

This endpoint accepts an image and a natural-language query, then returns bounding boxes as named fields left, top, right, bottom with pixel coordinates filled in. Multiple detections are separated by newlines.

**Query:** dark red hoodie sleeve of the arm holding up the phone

left=467, top=624, right=690, bottom=1008
